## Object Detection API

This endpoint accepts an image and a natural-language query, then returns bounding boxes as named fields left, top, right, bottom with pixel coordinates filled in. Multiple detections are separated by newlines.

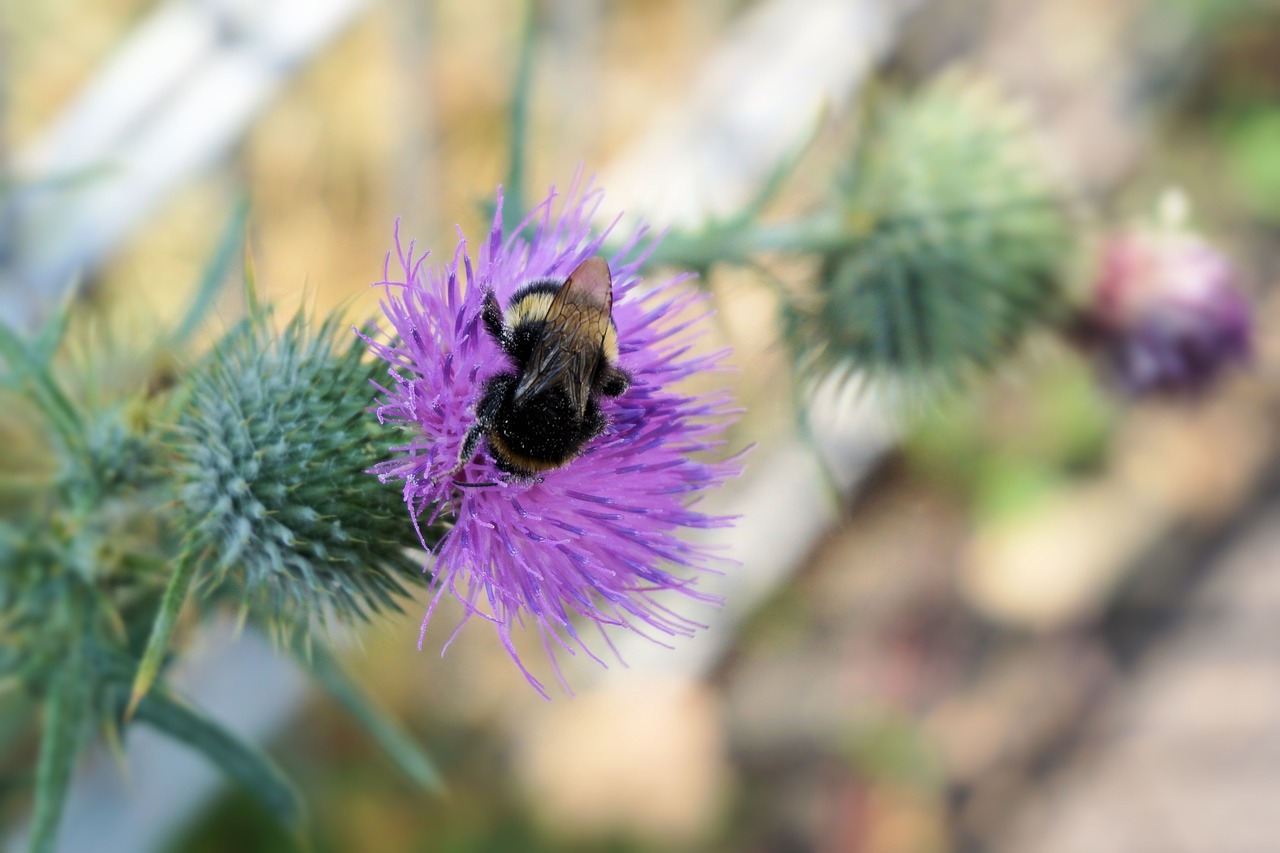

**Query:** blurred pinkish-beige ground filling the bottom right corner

left=992, top=500, right=1280, bottom=853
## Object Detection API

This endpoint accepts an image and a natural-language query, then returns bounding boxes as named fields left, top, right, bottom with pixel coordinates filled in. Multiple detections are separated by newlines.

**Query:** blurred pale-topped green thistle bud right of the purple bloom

left=796, top=76, right=1071, bottom=384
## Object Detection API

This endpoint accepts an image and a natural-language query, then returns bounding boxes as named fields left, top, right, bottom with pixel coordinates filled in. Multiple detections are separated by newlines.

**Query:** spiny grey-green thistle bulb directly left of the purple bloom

left=177, top=313, right=421, bottom=626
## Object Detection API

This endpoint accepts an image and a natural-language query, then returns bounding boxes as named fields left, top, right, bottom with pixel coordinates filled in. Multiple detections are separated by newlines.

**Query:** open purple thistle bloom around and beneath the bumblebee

left=360, top=184, right=740, bottom=695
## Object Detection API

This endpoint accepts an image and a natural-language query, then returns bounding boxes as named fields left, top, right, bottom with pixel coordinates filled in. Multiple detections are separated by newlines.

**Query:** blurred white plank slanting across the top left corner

left=0, top=0, right=369, bottom=325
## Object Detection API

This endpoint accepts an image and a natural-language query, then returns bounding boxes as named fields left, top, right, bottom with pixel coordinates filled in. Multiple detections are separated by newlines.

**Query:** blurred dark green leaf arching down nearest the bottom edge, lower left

left=136, top=688, right=306, bottom=834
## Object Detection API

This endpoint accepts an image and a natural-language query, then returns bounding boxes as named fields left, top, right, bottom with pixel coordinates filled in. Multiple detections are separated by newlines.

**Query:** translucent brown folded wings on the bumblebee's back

left=513, top=257, right=613, bottom=415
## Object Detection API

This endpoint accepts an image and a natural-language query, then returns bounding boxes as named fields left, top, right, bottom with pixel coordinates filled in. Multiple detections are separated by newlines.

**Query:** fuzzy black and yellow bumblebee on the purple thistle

left=454, top=257, right=631, bottom=480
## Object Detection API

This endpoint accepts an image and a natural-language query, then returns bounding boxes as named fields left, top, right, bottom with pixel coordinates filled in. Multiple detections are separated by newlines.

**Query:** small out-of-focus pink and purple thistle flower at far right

left=1074, top=205, right=1252, bottom=397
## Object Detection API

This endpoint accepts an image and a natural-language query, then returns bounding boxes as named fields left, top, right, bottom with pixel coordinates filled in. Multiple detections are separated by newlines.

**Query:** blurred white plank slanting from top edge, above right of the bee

left=600, top=0, right=920, bottom=227
